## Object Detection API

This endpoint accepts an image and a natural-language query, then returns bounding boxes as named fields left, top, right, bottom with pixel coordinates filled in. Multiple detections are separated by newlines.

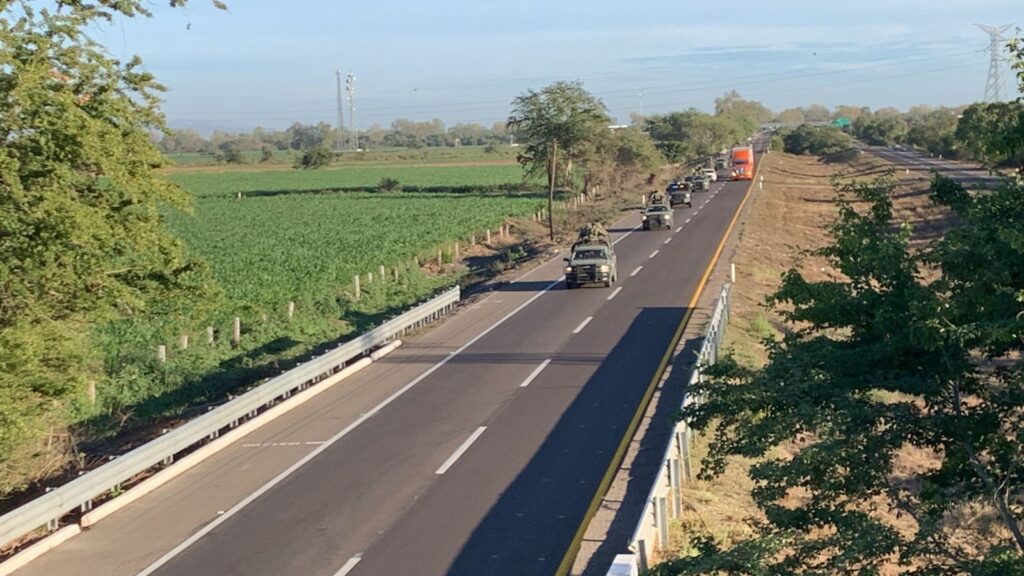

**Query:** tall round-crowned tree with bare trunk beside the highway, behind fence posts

left=508, top=82, right=610, bottom=240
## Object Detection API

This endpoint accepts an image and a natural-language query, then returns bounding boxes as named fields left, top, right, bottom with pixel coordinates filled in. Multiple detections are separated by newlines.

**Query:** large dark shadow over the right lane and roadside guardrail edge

left=446, top=307, right=697, bottom=576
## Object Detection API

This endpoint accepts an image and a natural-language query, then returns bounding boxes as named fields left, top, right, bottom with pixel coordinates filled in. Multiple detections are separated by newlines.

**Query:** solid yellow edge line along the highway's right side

left=555, top=152, right=761, bottom=576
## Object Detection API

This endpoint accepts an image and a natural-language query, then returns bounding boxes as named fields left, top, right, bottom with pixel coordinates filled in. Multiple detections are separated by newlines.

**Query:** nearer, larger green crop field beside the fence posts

left=169, top=189, right=542, bottom=308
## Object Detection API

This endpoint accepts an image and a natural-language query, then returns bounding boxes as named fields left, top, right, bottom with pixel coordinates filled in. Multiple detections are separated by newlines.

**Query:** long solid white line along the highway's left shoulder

left=137, top=276, right=565, bottom=576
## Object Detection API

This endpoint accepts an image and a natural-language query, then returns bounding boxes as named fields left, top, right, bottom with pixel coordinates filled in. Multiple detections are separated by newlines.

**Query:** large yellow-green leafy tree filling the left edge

left=0, top=0, right=218, bottom=474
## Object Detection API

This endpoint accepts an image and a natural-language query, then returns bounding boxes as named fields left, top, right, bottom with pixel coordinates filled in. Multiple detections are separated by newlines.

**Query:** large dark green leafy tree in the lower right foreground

left=657, top=172, right=1024, bottom=575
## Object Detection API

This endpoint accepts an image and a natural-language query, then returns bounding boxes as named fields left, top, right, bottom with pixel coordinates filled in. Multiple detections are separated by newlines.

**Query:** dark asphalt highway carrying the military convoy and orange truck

left=17, top=154, right=750, bottom=576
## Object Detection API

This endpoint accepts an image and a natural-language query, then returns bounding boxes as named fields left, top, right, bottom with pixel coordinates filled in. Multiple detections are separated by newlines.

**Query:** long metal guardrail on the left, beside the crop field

left=0, top=286, right=462, bottom=545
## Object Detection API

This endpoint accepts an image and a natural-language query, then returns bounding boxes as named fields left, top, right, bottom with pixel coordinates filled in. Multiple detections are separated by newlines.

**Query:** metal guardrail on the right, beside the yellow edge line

left=608, top=284, right=732, bottom=576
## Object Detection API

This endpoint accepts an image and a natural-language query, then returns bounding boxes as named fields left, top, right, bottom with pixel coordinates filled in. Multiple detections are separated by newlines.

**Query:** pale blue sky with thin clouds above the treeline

left=92, top=0, right=1024, bottom=133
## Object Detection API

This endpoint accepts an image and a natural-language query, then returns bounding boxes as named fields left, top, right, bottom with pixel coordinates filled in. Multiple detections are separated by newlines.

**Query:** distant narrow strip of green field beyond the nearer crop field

left=168, top=164, right=522, bottom=198
